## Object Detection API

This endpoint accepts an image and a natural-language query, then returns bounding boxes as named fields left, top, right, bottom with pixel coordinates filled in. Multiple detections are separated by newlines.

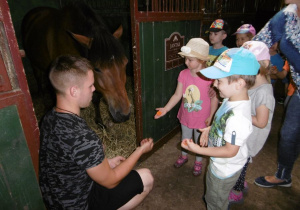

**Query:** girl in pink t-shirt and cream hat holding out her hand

left=154, top=38, right=218, bottom=176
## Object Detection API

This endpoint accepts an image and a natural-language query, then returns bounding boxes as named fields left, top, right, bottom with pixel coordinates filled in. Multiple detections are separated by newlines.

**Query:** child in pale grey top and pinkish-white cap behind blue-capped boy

left=228, top=41, right=275, bottom=205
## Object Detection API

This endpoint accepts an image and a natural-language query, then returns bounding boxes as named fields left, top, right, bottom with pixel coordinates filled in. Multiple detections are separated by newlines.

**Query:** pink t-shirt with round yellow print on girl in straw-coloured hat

left=177, top=69, right=212, bottom=129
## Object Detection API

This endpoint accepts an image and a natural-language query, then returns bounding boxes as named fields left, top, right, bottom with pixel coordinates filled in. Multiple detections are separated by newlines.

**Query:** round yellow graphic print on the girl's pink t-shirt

left=183, top=85, right=203, bottom=112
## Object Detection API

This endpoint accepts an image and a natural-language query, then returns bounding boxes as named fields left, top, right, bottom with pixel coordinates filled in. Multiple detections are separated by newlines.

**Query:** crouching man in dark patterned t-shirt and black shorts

left=39, top=55, right=153, bottom=210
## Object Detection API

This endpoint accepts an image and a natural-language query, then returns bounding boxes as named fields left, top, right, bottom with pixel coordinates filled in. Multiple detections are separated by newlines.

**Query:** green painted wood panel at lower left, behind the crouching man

left=0, top=106, right=45, bottom=210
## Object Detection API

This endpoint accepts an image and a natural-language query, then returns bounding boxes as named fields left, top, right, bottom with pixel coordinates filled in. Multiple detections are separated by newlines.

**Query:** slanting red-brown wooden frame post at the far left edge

left=0, top=1, right=39, bottom=177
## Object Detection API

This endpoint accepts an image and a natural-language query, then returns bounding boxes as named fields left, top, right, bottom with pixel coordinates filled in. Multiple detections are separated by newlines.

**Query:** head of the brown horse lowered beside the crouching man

left=71, top=26, right=131, bottom=123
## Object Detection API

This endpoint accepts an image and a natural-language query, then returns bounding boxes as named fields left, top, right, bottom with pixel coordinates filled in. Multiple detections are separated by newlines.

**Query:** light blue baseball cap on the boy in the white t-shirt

left=200, top=48, right=260, bottom=79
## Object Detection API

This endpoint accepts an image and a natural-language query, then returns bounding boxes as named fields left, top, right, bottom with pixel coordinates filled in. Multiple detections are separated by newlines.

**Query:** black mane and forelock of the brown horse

left=66, top=0, right=126, bottom=67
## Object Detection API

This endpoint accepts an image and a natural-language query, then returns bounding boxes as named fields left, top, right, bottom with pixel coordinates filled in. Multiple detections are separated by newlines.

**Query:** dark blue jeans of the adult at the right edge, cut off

left=275, top=91, right=300, bottom=181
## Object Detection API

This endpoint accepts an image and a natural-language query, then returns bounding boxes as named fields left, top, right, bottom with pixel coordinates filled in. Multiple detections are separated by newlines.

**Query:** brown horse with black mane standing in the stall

left=22, top=1, right=130, bottom=124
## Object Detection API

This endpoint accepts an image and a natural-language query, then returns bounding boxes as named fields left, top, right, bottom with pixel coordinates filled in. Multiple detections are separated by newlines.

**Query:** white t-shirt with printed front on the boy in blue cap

left=209, top=99, right=253, bottom=179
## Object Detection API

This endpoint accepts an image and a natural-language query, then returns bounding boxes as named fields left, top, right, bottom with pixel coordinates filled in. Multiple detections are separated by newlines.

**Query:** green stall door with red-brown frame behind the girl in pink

left=130, top=0, right=204, bottom=148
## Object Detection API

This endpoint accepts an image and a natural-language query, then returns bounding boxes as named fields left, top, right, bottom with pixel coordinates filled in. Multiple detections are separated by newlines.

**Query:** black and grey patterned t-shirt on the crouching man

left=39, top=109, right=105, bottom=209
